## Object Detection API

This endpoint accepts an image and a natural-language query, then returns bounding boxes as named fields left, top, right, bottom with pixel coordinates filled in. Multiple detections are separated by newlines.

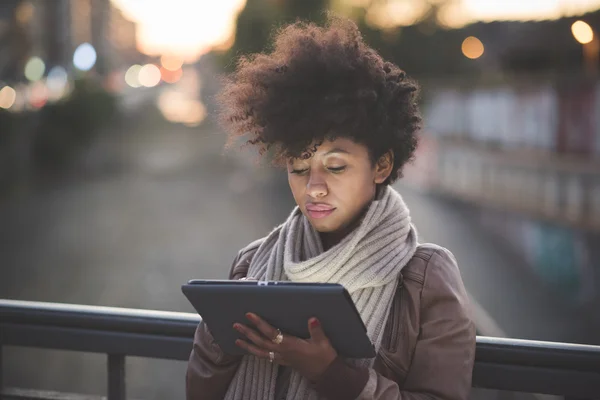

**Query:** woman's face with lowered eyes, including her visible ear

left=288, top=138, right=393, bottom=233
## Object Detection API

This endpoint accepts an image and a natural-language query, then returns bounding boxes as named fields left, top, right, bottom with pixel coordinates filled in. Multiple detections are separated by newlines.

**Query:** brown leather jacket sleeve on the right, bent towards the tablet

left=317, top=249, right=475, bottom=400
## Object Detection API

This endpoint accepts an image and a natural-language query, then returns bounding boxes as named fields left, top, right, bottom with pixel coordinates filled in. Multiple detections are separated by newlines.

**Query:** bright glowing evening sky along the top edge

left=112, top=0, right=600, bottom=61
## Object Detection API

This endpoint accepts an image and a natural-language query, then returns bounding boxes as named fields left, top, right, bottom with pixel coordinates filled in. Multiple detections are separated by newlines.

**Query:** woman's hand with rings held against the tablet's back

left=233, top=313, right=337, bottom=381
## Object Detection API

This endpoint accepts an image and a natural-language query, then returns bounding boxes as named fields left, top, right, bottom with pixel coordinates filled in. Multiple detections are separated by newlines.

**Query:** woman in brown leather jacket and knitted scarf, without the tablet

left=187, top=19, right=475, bottom=400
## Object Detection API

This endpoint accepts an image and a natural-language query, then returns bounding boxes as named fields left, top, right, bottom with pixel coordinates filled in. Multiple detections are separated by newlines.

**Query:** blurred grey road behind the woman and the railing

left=0, top=110, right=597, bottom=399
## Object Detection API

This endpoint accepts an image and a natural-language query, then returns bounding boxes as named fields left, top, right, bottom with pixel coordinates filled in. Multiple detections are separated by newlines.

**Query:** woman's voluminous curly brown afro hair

left=217, top=17, right=421, bottom=184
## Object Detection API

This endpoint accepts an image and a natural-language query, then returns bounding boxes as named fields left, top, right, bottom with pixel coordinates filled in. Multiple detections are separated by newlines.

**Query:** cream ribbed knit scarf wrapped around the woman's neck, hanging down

left=225, top=186, right=417, bottom=400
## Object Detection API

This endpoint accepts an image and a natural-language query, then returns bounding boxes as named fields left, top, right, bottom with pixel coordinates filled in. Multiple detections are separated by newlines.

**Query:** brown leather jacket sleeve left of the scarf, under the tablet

left=185, top=251, right=243, bottom=400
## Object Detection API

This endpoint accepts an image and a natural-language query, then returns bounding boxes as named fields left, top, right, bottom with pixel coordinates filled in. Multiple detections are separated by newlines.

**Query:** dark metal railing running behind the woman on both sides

left=0, top=299, right=600, bottom=400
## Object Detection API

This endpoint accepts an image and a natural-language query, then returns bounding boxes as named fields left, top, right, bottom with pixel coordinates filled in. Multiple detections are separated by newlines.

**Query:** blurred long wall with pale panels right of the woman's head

left=407, top=59, right=600, bottom=322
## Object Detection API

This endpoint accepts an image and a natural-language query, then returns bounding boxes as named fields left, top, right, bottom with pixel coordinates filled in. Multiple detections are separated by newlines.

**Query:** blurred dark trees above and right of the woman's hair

left=222, top=0, right=600, bottom=82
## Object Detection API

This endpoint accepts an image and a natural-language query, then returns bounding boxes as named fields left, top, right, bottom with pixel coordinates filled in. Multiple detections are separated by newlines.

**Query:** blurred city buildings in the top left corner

left=0, top=0, right=140, bottom=81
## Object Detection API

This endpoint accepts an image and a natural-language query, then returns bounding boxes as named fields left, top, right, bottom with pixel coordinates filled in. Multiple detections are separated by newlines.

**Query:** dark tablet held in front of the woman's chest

left=181, top=280, right=376, bottom=358
